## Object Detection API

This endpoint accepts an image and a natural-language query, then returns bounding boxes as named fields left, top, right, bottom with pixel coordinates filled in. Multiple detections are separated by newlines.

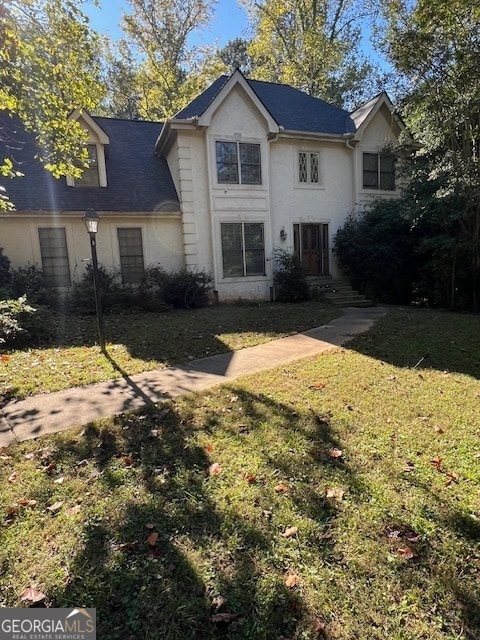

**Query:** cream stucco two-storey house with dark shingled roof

left=0, top=71, right=404, bottom=300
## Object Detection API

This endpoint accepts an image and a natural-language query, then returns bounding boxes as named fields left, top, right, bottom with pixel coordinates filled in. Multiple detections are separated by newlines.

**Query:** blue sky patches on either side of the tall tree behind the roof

left=83, top=0, right=247, bottom=46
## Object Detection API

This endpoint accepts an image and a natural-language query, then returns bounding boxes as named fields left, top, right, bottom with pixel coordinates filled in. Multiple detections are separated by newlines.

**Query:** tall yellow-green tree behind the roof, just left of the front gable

left=123, top=0, right=214, bottom=119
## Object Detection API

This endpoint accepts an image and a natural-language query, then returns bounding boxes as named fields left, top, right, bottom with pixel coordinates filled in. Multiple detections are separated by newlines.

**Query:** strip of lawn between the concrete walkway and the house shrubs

left=0, top=302, right=339, bottom=398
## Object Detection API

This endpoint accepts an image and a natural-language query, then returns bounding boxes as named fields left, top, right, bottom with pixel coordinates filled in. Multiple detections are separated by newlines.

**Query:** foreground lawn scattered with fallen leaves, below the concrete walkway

left=0, top=309, right=480, bottom=640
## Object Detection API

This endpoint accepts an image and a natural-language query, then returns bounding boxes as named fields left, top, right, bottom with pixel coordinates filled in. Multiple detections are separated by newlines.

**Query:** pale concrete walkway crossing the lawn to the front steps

left=0, top=307, right=385, bottom=447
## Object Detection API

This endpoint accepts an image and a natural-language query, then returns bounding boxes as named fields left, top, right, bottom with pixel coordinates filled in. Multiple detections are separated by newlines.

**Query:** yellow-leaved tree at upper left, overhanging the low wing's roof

left=0, top=0, right=103, bottom=209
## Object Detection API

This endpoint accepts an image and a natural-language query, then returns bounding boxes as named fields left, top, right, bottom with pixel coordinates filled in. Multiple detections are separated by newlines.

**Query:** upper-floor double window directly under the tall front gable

left=215, top=142, right=262, bottom=184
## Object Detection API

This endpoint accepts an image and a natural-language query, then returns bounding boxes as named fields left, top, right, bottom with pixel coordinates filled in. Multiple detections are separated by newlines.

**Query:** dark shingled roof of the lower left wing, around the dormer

left=0, top=112, right=179, bottom=213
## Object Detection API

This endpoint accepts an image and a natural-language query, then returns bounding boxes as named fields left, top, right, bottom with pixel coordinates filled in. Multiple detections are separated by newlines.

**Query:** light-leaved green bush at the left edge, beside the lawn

left=0, top=296, right=55, bottom=348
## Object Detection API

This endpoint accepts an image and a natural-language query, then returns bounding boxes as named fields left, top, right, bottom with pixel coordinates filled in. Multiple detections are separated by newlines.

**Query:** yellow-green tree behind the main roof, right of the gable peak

left=244, top=0, right=384, bottom=106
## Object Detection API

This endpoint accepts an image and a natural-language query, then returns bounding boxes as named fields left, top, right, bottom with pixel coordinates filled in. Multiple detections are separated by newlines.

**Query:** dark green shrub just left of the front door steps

left=273, top=249, right=310, bottom=302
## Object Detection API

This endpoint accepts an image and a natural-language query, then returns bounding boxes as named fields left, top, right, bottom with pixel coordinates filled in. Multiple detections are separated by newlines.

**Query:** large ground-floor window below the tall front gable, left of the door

left=221, top=222, right=265, bottom=278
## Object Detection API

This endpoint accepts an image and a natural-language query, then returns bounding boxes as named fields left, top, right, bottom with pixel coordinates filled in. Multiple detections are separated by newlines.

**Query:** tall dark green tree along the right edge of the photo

left=384, top=0, right=480, bottom=308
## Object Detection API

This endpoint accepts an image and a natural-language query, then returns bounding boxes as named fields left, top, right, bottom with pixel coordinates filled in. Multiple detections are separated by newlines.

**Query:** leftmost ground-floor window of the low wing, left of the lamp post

left=38, top=227, right=70, bottom=287
